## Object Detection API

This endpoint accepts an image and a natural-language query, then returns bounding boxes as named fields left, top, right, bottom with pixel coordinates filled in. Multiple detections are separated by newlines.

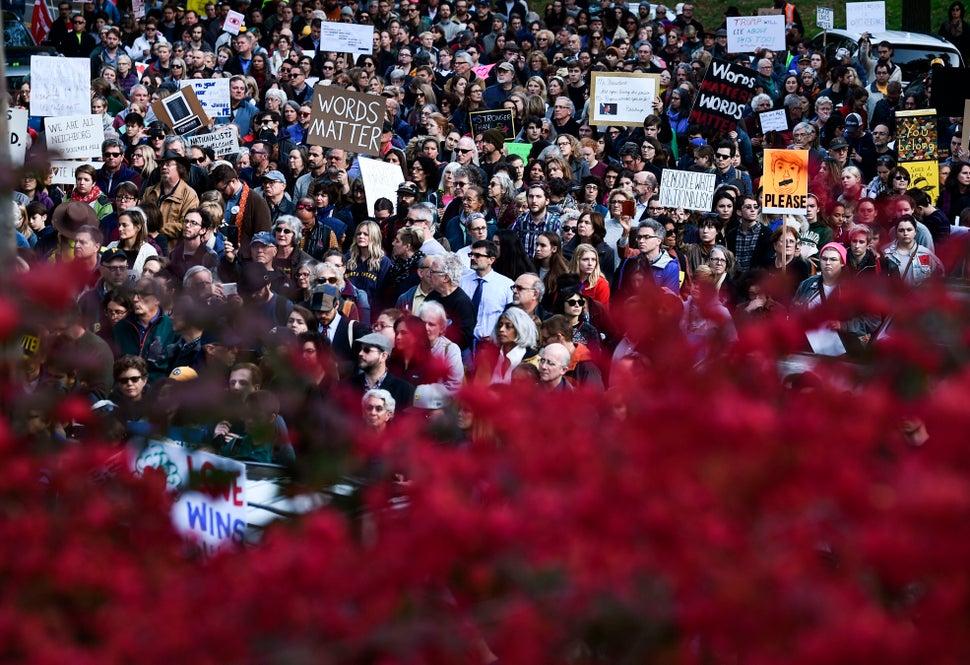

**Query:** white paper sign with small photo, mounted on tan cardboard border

left=589, top=72, right=660, bottom=127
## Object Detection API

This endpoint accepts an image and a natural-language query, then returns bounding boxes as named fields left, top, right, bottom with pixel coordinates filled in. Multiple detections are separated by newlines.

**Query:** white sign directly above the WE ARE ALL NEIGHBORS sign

left=30, top=55, right=91, bottom=116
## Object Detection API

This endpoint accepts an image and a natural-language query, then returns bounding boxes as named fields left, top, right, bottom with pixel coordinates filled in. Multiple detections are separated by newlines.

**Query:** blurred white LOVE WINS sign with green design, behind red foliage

left=131, top=441, right=246, bottom=552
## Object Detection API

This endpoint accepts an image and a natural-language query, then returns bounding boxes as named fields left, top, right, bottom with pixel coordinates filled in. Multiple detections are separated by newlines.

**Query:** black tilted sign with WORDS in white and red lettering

left=690, top=60, right=756, bottom=134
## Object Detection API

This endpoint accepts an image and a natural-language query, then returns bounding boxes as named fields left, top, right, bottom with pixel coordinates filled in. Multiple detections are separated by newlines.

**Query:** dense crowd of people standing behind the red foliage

left=14, top=0, right=970, bottom=462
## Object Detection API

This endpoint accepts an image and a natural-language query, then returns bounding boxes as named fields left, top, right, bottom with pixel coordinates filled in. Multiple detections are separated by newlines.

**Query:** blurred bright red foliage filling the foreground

left=0, top=262, right=970, bottom=665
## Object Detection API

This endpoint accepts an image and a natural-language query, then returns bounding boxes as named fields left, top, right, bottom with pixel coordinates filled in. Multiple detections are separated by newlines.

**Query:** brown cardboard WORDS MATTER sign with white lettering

left=306, top=85, right=387, bottom=155
